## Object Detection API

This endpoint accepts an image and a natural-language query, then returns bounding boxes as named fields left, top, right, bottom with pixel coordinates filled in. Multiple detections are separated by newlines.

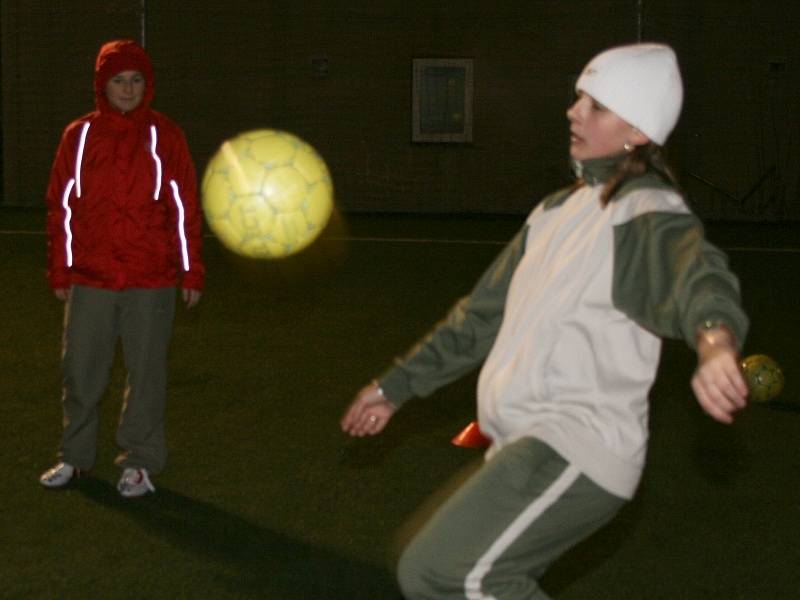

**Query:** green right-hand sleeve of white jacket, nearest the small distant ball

left=613, top=212, right=749, bottom=349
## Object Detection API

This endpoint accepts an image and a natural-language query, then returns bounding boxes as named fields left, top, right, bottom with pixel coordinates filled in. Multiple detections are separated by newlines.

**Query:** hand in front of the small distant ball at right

left=692, top=330, right=748, bottom=424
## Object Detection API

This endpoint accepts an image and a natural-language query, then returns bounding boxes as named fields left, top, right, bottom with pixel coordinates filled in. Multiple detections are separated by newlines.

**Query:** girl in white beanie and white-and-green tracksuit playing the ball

left=341, top=44, right=748, bottom=600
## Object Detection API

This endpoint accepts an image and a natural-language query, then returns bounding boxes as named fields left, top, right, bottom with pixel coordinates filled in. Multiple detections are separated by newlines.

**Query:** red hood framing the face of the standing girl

left=94, top=40, right=155, bottom=112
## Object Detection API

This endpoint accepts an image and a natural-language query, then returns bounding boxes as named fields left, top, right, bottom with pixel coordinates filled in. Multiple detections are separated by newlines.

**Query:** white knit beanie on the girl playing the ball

left=575, top=44, right=683, bottom=146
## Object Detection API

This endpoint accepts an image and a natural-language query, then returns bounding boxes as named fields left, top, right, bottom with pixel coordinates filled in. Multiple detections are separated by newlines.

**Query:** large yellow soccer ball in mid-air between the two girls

left=202, top=129, right=333, bottom=259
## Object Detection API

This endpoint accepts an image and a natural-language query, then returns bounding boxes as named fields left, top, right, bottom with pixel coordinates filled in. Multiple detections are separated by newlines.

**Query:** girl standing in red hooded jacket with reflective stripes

left=40, top=40, right=204, bottom=497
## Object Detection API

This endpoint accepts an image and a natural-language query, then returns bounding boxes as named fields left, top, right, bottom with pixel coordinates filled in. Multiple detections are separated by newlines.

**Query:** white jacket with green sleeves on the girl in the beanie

left=380, top=160, right=748, bottom=498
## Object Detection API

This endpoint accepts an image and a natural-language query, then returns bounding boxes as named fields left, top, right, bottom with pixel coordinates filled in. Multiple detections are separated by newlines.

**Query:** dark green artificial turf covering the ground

left=0, top=209, right=800, bottom=600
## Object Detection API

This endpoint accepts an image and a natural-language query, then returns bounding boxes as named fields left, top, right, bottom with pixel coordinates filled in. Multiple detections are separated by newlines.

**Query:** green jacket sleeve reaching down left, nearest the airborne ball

left=379, top=226, right=528, bottom=406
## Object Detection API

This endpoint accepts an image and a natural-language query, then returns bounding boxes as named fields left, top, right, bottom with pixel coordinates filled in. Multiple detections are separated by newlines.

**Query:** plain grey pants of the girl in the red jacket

left=59, top=285, right=175, bottom=473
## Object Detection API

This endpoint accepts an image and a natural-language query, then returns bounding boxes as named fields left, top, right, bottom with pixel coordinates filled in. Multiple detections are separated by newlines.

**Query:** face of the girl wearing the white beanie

left=567, top=92, right=650, bottom=160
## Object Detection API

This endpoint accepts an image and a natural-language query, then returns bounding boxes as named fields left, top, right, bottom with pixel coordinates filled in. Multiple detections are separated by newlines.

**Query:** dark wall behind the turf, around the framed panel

left=2, top=0, right=800, bottom=219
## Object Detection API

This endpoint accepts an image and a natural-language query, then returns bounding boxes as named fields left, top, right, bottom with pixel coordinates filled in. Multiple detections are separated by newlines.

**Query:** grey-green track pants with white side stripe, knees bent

left=398, top=438, right=625, bottom=600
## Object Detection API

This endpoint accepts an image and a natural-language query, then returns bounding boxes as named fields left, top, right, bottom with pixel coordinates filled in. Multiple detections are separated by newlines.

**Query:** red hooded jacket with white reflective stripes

left=47, top=40, right=205, bottom=290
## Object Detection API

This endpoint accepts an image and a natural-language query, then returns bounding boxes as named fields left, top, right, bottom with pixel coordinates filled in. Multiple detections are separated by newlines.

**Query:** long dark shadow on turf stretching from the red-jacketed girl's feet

left=76, top=479, right=400, bottom=600
